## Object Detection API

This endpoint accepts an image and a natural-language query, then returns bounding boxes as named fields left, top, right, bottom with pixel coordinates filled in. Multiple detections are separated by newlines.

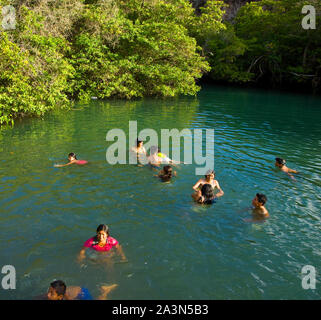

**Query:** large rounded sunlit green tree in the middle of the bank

left=71, top=1, right=209, bottom=99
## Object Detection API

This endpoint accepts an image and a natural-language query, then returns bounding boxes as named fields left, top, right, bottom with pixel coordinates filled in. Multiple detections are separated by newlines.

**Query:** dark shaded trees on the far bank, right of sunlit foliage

left=235, top=0, right=321, bottom=90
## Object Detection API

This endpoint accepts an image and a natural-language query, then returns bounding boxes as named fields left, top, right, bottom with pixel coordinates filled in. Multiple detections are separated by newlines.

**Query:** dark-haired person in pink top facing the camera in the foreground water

left=78, top=224, right=127, bottom=261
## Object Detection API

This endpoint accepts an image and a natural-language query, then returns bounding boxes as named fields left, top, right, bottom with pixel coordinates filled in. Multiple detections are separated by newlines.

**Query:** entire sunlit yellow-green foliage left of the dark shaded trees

left=0, top=0, right=216, bottom=123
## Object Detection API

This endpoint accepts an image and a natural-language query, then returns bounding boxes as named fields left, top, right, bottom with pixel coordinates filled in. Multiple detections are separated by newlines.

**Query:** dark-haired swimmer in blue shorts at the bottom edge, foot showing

left=46, top=280, right=118, bottom=300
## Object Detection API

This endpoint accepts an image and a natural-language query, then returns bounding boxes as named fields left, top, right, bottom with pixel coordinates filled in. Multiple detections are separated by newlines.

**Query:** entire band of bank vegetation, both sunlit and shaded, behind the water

left=0, top=0, right=321, bottom=124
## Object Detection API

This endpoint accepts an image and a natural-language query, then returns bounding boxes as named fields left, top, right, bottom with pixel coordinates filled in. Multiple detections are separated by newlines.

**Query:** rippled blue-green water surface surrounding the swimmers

left=0, top=87, right=321, bottom=299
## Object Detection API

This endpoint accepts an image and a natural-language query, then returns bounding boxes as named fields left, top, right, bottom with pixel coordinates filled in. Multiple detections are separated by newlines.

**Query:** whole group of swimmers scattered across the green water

left=46, top=139, right=298, bottom=300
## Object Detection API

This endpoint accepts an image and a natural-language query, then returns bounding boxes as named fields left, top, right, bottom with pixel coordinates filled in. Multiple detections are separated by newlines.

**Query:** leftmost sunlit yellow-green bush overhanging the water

left=0, top=2, right=73, bottom=124
